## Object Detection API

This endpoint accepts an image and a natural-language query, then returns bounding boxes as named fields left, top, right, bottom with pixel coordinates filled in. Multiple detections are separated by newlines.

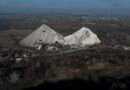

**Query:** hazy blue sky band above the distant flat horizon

left=0, top=0, right=130, bottom=13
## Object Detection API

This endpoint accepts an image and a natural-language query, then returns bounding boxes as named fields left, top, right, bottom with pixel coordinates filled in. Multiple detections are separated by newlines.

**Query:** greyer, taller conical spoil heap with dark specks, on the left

left=20, top=25, right=65, bottom=48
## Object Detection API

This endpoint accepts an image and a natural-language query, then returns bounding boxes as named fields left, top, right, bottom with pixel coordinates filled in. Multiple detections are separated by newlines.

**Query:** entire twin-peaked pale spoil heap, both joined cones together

left=20, top=25, right=101, bottom=50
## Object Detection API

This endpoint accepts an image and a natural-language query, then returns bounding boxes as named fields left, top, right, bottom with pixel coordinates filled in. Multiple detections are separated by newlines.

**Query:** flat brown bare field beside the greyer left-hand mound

left=0, top=30, right=33, bottom=47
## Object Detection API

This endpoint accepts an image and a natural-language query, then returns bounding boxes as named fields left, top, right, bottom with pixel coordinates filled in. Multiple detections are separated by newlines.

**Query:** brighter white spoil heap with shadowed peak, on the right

left=64, top=27, right=101, bottom=47
